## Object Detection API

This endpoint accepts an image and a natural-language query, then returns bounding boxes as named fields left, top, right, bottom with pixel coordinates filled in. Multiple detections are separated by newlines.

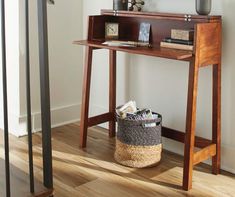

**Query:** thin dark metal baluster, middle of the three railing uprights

left=25, top=0, right=34, bottom=193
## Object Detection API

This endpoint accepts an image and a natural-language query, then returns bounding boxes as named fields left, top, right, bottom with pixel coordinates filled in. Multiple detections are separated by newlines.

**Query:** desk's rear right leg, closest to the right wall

left=212, top=64, right=221, bottom=174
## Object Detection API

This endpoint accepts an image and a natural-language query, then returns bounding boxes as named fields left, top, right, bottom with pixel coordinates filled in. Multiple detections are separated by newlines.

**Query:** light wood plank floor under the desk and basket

left=0, top=124, right=235, bottom=197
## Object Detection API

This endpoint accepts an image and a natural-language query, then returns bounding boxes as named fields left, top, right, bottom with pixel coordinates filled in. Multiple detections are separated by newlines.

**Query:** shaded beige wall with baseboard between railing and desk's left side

left=20, top=0, right=82, bottom=130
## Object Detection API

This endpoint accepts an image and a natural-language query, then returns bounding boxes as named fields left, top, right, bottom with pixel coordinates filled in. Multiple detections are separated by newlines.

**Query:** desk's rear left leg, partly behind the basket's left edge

left=109, top=50, right=116, bottom=137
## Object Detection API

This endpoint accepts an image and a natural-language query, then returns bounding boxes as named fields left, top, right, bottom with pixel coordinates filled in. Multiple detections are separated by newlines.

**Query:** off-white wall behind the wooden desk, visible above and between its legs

left=83, top=0, right=235, bottom=172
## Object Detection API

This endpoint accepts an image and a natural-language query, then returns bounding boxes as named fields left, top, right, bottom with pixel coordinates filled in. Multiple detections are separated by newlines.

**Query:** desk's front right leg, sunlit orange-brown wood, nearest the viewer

left=183, top=59, right=198, bottom=190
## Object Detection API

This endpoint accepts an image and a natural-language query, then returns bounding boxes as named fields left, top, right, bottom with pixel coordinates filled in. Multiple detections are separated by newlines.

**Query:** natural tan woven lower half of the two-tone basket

left=114, top=139, right=162, bottom=168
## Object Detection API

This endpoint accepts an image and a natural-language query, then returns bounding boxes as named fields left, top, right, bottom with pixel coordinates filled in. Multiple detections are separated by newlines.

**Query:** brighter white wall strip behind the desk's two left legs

left=83, top=0, right=130, bottom=118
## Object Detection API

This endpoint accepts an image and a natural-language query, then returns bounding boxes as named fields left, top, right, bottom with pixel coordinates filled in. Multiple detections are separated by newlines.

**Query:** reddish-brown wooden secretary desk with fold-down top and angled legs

left=74, top=10, right=221, bottom=190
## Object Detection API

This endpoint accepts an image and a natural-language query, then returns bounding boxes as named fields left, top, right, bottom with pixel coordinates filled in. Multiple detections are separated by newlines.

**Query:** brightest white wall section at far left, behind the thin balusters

left=0, top=0, right=20, bottom=134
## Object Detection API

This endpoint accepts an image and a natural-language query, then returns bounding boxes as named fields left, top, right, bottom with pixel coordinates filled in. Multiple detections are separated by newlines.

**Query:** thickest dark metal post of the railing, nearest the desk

left=37, top=0, right=53, bottom=188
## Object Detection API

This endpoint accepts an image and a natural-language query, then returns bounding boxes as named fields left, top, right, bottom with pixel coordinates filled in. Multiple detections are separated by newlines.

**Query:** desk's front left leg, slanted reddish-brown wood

left=80, top=47, right=93, bottom=148
